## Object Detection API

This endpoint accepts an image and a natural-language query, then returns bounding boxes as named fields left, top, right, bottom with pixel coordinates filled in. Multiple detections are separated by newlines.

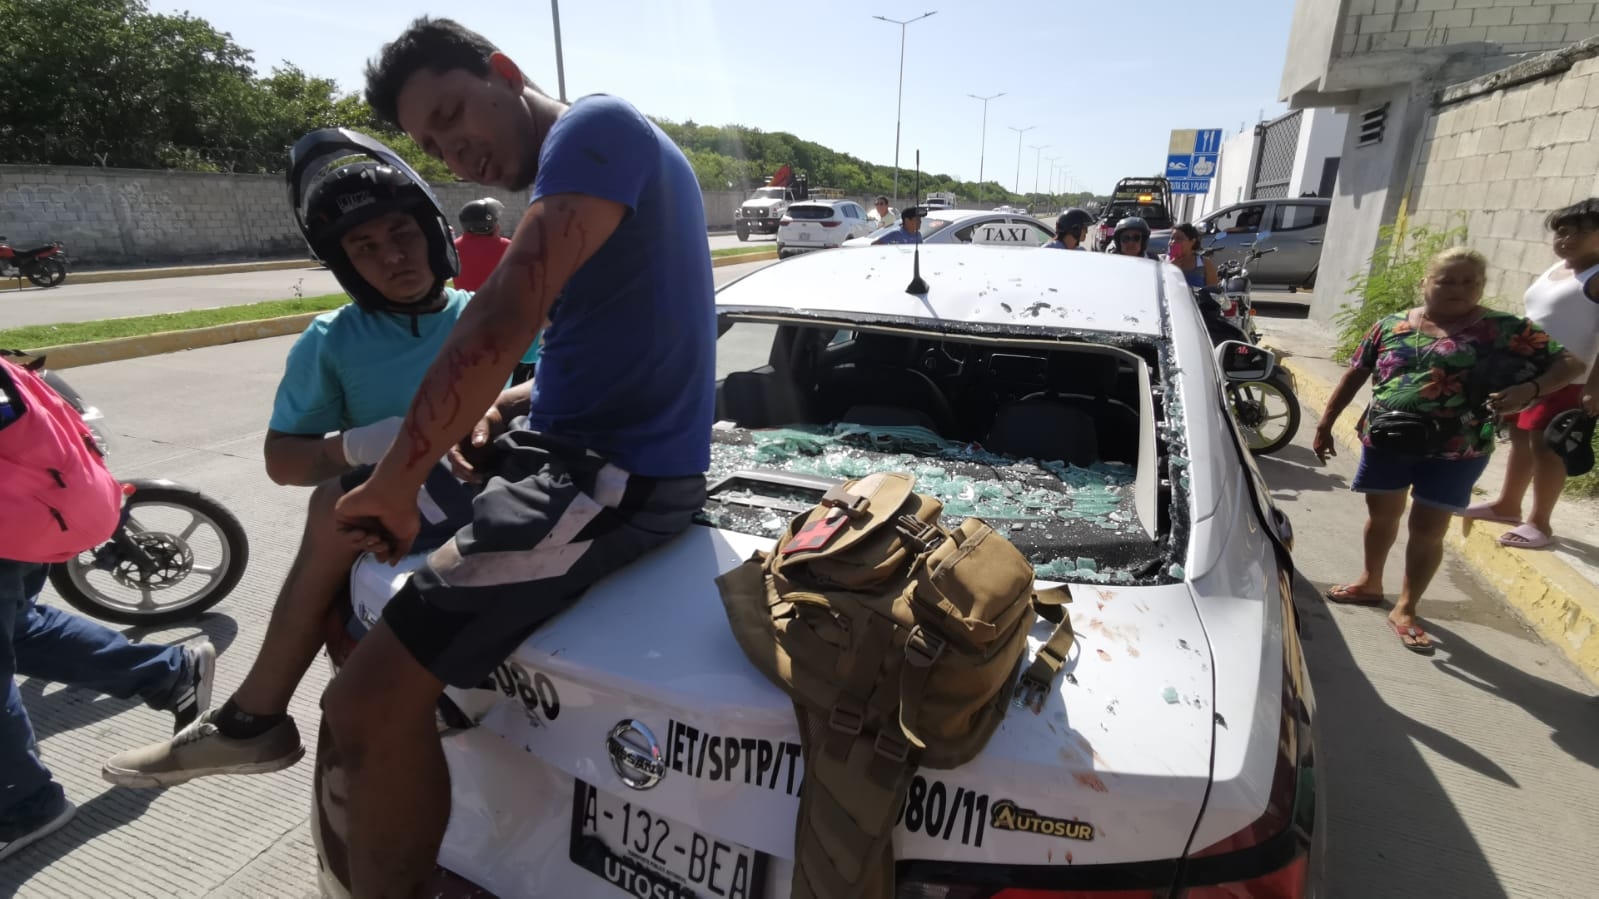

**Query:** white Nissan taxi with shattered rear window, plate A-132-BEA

left=313, top=245, right=1326, bottom=899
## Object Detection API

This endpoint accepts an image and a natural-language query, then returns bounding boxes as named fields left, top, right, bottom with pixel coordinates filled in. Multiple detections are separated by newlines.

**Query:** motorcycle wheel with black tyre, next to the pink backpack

left=50, top=481, right=249, bottom=625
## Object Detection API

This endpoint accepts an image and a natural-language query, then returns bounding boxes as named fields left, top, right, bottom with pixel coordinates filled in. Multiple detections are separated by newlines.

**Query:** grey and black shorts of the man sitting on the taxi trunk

left=344, top=430, right=705, bottom=688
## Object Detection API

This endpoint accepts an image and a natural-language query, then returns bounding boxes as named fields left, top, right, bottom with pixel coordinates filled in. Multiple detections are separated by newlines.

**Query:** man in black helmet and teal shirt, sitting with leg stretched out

left=101, top=128, right=486, bottom=787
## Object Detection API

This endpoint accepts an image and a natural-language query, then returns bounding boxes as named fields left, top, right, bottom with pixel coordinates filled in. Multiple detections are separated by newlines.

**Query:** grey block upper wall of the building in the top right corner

left=1337, top=0, right=1599, bottom=58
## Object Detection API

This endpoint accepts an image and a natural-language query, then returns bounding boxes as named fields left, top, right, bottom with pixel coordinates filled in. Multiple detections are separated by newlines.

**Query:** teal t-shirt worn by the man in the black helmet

left=267, top=288, right=472, bottom=434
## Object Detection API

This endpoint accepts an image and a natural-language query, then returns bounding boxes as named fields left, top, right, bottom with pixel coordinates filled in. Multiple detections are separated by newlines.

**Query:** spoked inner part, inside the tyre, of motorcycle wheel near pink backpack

left=59, top=499, right=241, bottom=621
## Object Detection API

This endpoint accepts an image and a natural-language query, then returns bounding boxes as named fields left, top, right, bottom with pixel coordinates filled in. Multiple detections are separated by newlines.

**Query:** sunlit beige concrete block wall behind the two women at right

left=1409, top=48, right=1599, bottom=303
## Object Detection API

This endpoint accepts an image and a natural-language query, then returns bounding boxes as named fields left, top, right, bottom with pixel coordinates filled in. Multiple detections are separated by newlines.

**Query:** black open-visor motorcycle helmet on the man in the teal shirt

left=288, top=128, right=461, bottom=314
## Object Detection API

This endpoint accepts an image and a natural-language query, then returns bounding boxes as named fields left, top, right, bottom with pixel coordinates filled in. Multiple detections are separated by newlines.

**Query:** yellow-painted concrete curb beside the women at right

left=1263, top=347, right=1599, bottom=683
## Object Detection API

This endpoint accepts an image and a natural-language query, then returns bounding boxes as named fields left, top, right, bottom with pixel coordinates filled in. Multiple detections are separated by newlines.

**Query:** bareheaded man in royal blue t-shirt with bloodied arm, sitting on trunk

left=188, top=18, right=716, bottom=896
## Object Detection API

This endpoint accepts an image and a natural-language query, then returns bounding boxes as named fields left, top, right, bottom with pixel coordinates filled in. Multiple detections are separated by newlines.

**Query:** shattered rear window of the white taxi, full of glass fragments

left=702, top=312, right=1182, bottom=584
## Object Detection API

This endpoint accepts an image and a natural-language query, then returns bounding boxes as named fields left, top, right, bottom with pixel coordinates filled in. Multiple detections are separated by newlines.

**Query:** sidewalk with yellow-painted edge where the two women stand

left=1260, top=307, right=1599, bottom=683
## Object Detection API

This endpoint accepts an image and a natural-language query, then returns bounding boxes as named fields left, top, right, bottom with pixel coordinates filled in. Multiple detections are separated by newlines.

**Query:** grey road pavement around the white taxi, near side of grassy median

left=0, top=310, right=1599, bottom=899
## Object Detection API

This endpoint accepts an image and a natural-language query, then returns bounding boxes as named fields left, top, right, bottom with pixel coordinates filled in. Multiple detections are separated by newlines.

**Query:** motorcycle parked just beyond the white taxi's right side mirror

left=1193, top=275, right=1300, bottom=456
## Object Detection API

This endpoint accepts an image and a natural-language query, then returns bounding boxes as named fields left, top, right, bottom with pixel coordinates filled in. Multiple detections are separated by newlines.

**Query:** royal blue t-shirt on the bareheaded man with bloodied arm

left=528, top=94, right=716, bottom=477
